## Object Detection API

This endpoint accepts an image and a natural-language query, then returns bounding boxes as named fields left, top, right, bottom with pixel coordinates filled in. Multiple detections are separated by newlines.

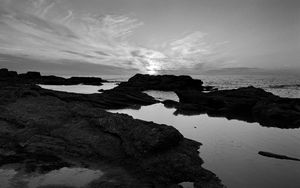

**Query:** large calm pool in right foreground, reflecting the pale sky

left=111, top=104, right=300, bottom=188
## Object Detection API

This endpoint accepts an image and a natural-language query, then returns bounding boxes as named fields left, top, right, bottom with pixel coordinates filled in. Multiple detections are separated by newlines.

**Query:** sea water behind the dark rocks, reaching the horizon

left=49, top=75, right=300, bottom=98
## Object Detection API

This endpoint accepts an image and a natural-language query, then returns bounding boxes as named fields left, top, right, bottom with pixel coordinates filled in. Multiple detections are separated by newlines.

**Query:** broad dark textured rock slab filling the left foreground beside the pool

left=0, top=81, right=223, bottom=188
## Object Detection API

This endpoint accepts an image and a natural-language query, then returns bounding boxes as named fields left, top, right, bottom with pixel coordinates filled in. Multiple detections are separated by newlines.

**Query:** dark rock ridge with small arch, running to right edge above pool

left=113, top=74, right=300, bottom=128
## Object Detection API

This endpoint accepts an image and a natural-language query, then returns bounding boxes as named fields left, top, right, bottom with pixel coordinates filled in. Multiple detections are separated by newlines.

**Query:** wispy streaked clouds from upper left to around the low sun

left=0, top=0, right=230, bottom=73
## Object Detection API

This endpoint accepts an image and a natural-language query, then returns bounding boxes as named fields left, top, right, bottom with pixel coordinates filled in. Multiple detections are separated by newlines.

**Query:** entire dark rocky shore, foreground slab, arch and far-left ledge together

left=0, top=69, right=300, bottom=188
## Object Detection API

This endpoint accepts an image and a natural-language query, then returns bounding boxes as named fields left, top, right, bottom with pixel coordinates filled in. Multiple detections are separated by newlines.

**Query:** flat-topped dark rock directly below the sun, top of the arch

left=115, top=74, right=205, bottom=91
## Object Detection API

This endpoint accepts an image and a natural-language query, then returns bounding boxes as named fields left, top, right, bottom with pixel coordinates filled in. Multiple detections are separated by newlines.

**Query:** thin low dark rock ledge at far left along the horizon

left=0, top=69, right=107, bottom=86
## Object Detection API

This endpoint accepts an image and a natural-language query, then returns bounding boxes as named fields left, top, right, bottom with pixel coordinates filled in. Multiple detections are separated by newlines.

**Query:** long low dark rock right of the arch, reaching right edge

left=176, top=86, right=300, bottom=128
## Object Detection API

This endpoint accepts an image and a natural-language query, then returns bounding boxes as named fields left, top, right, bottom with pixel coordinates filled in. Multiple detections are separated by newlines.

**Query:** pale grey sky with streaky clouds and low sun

left=0, top=0, right=300, bottom=74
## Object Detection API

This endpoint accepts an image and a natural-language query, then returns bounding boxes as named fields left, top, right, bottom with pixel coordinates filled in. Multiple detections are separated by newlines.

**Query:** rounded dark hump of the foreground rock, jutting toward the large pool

left=99, top=114, right=183, bottom=157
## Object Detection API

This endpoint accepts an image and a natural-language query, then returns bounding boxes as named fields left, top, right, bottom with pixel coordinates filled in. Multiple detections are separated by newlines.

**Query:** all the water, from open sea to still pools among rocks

left=0, top=75, right=300, bottom=188
